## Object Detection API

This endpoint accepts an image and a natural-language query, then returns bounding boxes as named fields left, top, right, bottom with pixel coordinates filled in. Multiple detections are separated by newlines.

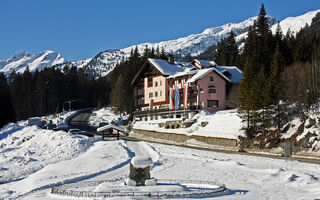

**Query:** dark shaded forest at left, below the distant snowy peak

left=0, top=66, right=110, bottom=126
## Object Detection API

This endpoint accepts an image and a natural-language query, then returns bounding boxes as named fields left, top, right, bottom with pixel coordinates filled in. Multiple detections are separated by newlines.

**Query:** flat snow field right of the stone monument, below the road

left=150, top=144, right=320, bottom=199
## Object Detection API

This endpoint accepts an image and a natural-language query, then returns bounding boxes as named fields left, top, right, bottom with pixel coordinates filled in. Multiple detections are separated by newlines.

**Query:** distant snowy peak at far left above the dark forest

left=0, top=50, right=66, bottom=75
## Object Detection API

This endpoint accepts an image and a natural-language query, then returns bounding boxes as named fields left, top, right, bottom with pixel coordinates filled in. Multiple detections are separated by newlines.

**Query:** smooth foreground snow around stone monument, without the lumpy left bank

left=0, top=133, right=320, bottom=199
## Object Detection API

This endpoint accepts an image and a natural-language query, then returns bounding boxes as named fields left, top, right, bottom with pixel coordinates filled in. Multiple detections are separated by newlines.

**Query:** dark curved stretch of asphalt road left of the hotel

left=68, top=109, right=97, bottom=134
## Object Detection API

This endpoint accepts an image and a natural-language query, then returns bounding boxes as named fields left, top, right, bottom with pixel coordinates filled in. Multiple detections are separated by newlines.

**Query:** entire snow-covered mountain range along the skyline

left=0, top=10, right=320, bottom=77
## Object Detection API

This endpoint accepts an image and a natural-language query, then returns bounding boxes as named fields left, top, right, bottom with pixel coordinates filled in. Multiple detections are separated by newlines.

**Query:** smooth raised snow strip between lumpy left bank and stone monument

left=0, top=141, right=131, bottom=199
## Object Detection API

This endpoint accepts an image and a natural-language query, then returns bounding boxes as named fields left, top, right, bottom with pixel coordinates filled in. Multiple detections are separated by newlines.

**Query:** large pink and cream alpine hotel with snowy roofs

left=131, top=56, right=242, bottom=120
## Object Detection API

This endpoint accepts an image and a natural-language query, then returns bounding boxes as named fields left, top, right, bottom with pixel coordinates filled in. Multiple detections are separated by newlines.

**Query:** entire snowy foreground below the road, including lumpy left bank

left=0, top=122, right=320, bottom=200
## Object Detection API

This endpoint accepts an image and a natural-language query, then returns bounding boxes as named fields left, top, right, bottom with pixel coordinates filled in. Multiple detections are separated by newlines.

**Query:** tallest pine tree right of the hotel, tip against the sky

left=238, top=4, right=273, bottom=138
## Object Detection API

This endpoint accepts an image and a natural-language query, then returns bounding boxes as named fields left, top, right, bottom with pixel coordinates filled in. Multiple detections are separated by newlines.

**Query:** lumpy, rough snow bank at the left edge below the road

left=0, top=124, right=92, bottom=182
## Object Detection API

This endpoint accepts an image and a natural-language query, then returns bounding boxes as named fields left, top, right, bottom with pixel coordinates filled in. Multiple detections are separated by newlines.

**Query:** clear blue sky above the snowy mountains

left=0, top=0, right=320, bottom=61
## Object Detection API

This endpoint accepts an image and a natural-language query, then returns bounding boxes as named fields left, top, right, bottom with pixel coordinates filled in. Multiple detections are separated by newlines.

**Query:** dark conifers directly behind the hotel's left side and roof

left=110, top=46, right=167, bottom=113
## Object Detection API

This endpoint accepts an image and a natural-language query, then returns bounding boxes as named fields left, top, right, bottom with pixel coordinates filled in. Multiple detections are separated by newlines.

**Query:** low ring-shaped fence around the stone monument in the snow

left=51, top=179, right=227, bottom=198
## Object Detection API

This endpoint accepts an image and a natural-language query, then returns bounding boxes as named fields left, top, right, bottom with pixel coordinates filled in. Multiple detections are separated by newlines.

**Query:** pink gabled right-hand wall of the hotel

left=197, top=71, right=226, bottom=110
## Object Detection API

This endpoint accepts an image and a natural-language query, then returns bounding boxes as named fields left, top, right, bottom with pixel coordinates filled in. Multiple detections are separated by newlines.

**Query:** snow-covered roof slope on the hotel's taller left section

left=148, top=58, right=195, bottom=75
